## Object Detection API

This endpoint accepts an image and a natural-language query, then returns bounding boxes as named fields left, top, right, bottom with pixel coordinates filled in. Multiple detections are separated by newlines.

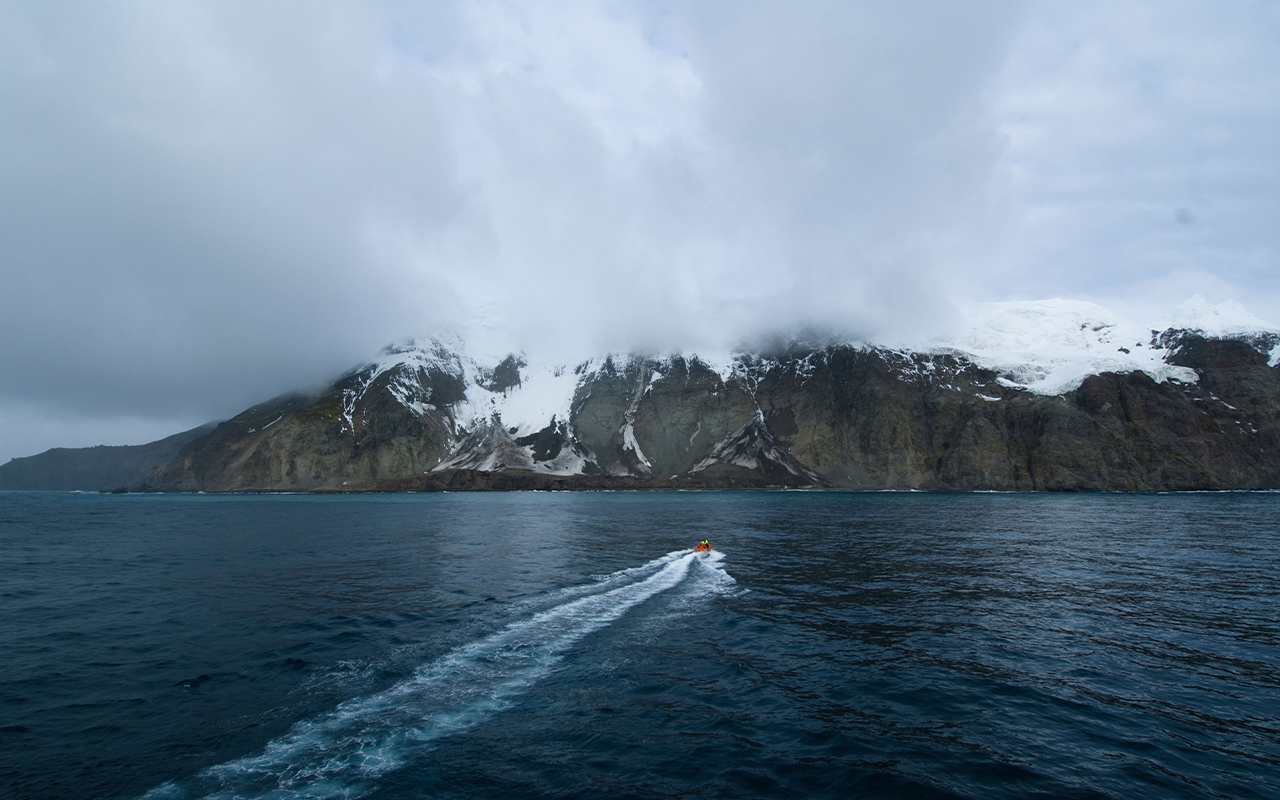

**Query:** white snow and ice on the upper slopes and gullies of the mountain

left=325, top=294, right=1280, bottom=460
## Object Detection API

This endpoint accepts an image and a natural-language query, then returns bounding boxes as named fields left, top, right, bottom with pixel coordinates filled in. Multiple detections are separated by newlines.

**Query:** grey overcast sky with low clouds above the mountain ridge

left=0, top=0, right=1280, bottom=462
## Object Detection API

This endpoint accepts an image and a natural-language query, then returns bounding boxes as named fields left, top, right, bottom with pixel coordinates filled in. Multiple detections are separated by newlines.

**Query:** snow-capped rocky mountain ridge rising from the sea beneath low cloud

left=112, top=297, right=1280, bottom=489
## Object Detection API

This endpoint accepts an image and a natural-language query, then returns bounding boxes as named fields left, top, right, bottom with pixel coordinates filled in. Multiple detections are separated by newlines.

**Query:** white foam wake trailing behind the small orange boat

left=143, top=550, right=733, bottom=800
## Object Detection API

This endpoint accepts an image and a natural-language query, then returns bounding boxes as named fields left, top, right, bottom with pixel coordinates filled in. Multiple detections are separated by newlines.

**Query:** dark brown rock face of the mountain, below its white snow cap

left=42, top=332, right=1280, bottom=492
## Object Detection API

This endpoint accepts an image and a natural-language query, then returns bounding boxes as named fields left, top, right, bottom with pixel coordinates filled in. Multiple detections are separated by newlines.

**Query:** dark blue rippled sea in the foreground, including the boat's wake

left=0, top=493, right=1280, bottom=800
